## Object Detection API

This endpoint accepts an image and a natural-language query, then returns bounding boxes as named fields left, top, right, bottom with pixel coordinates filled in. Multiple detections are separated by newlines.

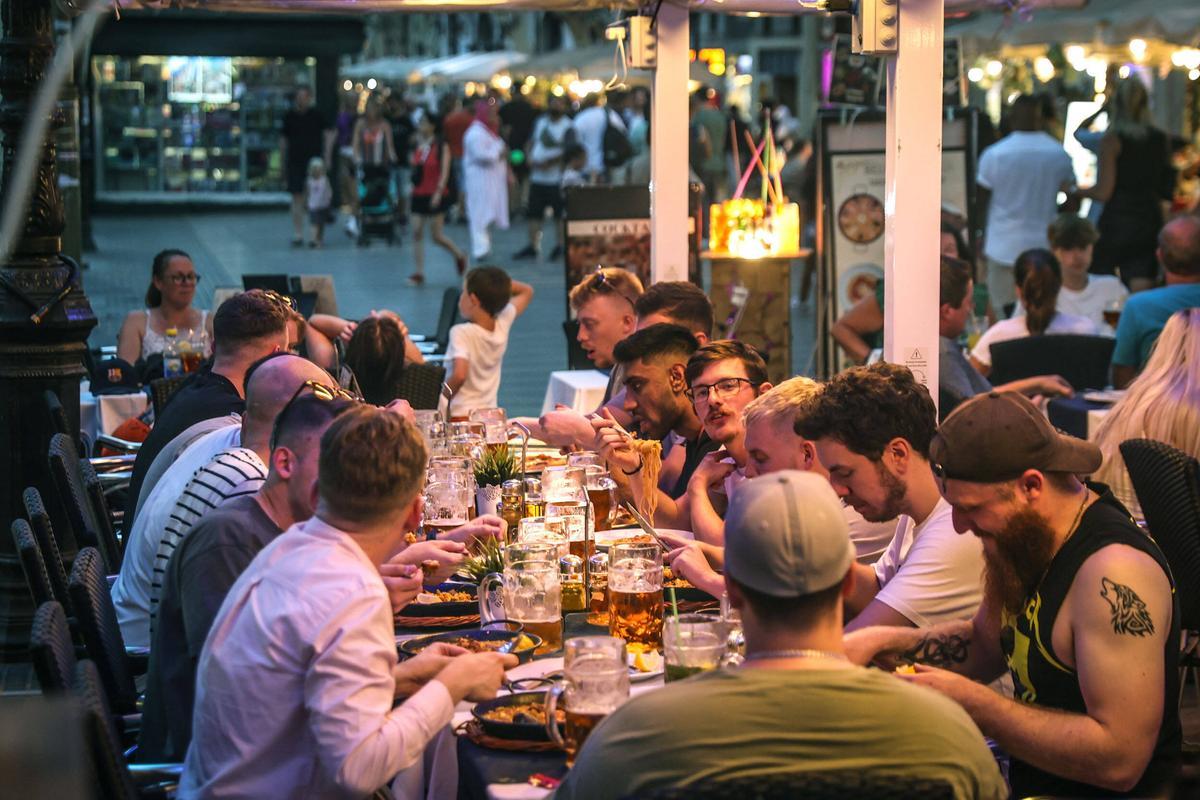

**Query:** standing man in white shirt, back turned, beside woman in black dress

left=977, top=95, right=1075, bottom=312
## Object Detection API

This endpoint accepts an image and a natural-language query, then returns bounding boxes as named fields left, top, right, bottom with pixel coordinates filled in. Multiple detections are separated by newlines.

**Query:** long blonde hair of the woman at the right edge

left=1092, top=308, right=1200, bottom=519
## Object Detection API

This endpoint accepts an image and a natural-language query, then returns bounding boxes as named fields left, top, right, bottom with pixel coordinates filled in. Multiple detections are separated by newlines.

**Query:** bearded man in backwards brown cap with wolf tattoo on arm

left=846, top=392, right=1182, bottom=796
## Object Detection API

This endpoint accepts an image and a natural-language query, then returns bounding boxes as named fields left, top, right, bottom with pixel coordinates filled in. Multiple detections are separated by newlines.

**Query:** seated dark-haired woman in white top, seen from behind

left=971, top=248, right=1099, bottom=377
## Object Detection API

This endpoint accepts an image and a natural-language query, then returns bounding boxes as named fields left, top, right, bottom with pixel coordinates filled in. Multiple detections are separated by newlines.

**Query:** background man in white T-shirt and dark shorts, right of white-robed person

left=512, top=95, right=577, bottom=260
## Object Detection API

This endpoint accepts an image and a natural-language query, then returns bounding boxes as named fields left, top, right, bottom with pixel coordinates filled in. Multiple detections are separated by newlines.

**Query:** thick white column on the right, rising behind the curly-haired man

left=883, top=0, right=943, bottom=403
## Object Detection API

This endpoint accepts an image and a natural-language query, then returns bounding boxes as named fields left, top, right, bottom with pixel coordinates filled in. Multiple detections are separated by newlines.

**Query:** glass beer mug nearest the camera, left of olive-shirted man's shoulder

left=546, top=636, right=629, bottom=766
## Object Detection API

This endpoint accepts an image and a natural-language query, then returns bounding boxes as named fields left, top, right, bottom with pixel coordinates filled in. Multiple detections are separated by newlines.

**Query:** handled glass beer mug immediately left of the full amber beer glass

left=479, top=542, right=563, bottom=655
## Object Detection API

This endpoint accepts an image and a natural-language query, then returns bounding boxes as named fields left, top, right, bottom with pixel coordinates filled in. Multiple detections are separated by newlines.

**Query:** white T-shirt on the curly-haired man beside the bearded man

left=875, top=499, right=983, bottom=627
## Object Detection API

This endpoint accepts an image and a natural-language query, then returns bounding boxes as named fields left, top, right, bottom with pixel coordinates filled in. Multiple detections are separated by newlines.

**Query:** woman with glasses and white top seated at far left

left=116, top=249, right=212, bottom=363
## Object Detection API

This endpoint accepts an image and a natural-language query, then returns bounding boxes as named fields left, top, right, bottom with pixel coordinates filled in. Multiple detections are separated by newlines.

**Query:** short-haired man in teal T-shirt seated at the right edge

left=1100, top=216, right=1200, bottom=389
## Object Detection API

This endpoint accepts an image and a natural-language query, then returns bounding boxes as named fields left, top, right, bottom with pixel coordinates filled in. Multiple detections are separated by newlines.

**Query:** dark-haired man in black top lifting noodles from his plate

left=593, top=323, right=720, bottom=528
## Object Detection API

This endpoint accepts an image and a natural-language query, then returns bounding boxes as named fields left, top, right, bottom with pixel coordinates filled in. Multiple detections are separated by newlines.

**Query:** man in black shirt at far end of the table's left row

left=124, top=289, right=304, bottom=530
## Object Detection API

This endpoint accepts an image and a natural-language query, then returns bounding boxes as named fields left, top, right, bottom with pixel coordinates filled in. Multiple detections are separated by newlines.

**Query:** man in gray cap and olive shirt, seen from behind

left=554, top=470, right=1008, bottom=800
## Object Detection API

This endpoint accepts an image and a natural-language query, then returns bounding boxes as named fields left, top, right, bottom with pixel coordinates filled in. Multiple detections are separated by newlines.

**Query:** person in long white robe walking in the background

left=462, top=101, right=511, bottom=261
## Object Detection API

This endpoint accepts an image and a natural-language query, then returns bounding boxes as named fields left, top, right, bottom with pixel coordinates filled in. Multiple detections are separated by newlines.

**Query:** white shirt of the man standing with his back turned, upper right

left=978, top=131, right=1075, bottom=264
